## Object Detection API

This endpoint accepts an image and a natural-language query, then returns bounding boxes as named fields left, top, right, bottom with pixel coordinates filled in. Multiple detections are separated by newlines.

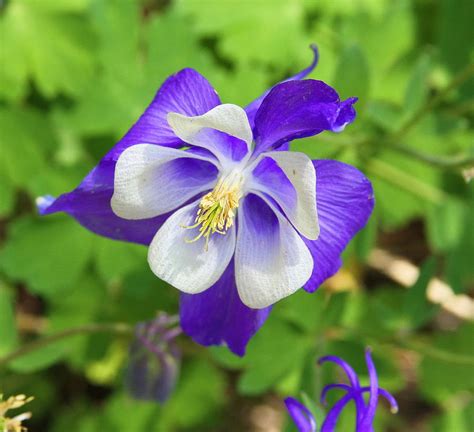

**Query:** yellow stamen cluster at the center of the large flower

left=183, top=171, right=243, bottom=250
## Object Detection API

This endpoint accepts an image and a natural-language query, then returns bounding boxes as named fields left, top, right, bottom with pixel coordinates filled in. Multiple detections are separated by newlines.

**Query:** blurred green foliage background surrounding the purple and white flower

left=0, top=0, right=474, bottom=432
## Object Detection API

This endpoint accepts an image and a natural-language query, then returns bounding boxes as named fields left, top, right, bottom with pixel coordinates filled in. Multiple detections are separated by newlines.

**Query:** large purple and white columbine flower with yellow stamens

left=38, top=49, right=374, bottom=355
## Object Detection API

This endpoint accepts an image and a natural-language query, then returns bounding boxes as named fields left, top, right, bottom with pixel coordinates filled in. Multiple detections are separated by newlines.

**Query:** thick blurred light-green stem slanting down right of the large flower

left=367, top=159, right=448, bottom=205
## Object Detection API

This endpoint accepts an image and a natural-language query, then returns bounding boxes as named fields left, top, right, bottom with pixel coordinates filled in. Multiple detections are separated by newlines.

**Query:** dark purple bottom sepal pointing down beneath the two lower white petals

left=180, top=261, right=271, bottom=356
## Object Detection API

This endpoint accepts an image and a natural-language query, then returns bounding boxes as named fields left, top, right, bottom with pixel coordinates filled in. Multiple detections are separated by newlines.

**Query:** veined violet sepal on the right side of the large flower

left=304, top=160, right=375, bottom=292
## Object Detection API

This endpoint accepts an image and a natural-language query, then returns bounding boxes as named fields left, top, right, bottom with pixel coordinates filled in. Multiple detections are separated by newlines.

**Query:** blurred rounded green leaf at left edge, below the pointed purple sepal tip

left=0, top=216, right=93, bottom=296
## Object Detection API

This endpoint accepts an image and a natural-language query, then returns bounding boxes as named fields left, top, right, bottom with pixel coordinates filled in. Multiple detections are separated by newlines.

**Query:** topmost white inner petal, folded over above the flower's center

left=167, top=104, right=252, bottom=160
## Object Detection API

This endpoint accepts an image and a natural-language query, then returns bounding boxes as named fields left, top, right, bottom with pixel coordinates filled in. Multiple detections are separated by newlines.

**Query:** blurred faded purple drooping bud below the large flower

left=126, top=314, right=181, bottom=403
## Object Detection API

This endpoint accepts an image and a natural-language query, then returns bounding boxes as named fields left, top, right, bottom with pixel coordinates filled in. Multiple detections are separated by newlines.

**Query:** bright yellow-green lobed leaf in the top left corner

left=0, top=0, right=94, bottom=99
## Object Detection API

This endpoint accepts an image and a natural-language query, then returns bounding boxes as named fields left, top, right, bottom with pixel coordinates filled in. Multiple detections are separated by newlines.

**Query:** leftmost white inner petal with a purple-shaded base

left=110, top=144, right=218, bottom=220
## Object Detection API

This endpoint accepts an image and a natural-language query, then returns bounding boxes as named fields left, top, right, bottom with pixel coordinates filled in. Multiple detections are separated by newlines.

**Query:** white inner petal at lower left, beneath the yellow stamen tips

left=148, top=202, right=235, bottom=294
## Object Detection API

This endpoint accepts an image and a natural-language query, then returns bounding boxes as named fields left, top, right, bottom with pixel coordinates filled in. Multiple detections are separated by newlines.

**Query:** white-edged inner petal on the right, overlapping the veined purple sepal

left=250, top=151, right=319, bottom=240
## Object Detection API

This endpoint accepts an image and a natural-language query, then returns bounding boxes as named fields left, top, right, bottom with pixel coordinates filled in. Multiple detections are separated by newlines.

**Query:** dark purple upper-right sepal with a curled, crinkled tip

left=254, top=80, right=357, bottom=155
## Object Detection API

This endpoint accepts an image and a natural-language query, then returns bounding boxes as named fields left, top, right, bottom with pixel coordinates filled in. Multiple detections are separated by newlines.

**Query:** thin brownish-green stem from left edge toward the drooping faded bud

left=0, top=323, right=133, bottom=368
